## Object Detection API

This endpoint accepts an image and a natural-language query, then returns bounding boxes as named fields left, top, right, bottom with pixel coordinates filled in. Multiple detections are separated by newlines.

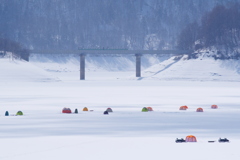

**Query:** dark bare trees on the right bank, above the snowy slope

left=178, top=3, right=240, bottom=59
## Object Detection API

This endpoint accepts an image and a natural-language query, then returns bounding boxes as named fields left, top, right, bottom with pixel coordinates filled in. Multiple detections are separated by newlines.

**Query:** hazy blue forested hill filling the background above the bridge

left=0, top=0, right=240, bottom=49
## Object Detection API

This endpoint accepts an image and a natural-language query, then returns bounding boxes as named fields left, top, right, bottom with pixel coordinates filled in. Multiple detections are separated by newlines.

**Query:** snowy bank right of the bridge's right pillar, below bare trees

left=141, top=56, right=240, bottom=81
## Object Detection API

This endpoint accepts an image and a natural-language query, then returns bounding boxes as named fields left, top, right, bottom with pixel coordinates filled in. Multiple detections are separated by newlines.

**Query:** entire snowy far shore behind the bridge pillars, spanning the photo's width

left=0, top=54, right=240, bottom=81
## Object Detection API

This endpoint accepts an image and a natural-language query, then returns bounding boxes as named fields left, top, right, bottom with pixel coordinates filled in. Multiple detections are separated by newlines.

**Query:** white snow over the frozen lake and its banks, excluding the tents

left=0, top=57, right=240, bottom=160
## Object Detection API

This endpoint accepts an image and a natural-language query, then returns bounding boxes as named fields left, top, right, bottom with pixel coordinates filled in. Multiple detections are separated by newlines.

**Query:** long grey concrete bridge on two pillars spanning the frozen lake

left=30, top=49, right=193, bottom=80
